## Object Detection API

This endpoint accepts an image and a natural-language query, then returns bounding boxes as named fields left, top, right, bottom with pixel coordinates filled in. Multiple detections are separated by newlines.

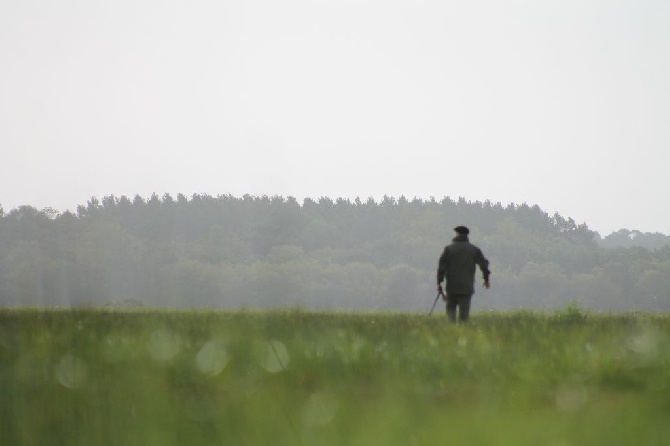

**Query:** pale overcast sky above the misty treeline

left=0, top=0, right=670, bottom=235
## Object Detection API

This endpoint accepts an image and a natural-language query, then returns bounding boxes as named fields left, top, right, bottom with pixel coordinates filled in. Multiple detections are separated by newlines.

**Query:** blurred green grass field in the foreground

left=0, top=308, right=670, bottom=446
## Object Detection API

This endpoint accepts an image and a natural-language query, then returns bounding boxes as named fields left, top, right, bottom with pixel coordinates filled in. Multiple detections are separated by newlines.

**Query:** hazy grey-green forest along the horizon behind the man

left=0, top=194, right=670, bottom=312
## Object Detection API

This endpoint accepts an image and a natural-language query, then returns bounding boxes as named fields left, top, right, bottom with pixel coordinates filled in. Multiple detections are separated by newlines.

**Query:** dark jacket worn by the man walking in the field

left=437, top=235, right=491, bottom=294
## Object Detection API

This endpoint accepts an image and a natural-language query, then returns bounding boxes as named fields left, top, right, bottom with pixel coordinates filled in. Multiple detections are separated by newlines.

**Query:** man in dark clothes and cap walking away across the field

left=437, top=226, right=491, bottom=322
